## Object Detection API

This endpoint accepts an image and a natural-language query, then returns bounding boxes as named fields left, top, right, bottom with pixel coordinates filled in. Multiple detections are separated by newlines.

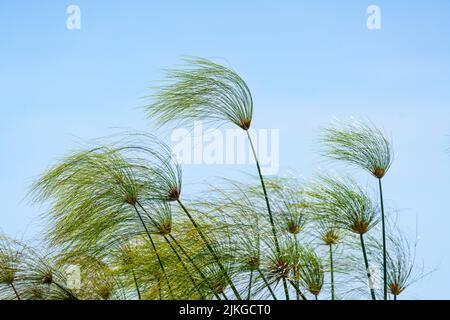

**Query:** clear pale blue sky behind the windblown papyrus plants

left=0, top=0, right=450, bottom=299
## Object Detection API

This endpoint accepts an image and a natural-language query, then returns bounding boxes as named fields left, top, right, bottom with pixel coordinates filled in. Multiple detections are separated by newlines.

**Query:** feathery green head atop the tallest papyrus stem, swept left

left=145, top=58, right=253, bottom=130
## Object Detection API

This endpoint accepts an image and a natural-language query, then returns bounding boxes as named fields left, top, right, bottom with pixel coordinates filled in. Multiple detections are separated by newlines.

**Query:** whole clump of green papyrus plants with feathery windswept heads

left=0, top=58, right=417, bottom=300
